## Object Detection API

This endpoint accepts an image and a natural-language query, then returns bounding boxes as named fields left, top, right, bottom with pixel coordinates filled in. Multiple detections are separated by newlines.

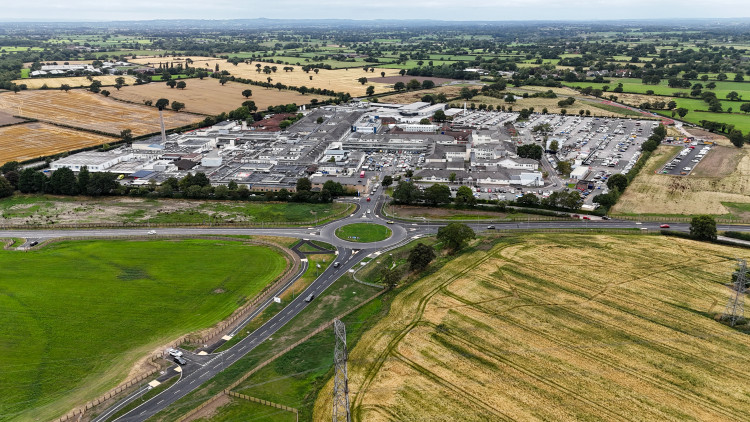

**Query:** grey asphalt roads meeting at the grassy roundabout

left=5, top=187, right=750, bottom=422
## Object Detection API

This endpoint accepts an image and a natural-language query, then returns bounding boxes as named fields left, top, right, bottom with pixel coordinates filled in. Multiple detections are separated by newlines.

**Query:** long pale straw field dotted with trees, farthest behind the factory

left=133, top=57, right=406, bottom=96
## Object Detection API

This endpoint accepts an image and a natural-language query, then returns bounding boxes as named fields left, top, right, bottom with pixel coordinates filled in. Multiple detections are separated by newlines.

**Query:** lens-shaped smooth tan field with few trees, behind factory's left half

left=111, top=78, right=328, bottom=115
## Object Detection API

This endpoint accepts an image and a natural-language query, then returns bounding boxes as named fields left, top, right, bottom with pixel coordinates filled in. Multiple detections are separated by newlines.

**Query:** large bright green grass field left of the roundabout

left=0, top=240, right=286, bottom=421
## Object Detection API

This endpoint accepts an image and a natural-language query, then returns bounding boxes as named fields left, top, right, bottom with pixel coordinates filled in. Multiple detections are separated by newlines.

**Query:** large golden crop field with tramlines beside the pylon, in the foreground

left=313, top=234, right=750, bottom=422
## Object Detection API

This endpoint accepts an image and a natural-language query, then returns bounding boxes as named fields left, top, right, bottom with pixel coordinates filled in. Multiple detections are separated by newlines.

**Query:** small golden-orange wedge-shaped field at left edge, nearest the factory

left=0, top=123, right=117, bottom=165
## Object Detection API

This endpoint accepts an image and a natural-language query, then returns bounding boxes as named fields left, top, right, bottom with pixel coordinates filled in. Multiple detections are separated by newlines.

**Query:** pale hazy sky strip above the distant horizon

left=0, top=0, right=750, bottom=21
